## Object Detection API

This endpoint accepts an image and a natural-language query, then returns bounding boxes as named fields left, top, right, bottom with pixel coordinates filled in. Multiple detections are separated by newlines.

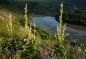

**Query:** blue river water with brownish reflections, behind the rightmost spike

left=31, top=16, right=86, bottom=38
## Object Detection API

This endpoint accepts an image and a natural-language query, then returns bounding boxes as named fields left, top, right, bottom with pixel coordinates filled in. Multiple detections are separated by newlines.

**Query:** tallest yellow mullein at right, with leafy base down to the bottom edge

left=40, top=2, right=68, bottom=59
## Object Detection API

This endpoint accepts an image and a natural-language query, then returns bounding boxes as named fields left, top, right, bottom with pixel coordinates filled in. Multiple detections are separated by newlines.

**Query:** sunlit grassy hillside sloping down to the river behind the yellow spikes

left=0, top=4, right=54, bottom=39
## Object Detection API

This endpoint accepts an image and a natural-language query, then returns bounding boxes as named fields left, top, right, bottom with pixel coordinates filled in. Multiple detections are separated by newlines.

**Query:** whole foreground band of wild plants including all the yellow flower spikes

left=0, top=2, right=86, bottom=59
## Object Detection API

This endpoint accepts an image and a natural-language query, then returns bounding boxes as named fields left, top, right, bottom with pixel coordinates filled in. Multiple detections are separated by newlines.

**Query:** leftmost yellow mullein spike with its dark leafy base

left=7, top=13, right=17, bottom=58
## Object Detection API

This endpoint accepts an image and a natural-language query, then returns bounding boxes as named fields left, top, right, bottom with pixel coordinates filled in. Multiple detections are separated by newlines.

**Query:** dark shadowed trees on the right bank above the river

left=56, top=9, right=86, bottom=26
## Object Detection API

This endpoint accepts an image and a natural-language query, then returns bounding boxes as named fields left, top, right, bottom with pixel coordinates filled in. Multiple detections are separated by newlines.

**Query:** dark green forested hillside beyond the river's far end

left=7, top=1, right=75, bottom=15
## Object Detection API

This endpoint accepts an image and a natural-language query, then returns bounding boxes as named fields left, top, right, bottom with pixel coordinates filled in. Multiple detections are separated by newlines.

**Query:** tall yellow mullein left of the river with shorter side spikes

left=24, top=4, right=36, bottom=39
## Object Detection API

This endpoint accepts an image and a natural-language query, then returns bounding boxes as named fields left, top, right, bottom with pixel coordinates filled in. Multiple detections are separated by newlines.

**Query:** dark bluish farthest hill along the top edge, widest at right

left=8, top=0, right=86, bottom=8
